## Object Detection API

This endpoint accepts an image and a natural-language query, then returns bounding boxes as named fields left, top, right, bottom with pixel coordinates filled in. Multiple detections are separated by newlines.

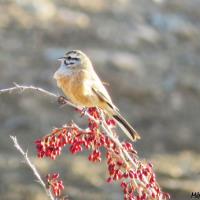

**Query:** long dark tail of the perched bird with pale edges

left=113, top=113, right=140, bottom=141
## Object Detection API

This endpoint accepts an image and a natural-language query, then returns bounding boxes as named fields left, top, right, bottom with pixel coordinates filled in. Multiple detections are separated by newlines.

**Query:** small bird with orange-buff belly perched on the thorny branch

left=53, top=50, right=140, bottom=141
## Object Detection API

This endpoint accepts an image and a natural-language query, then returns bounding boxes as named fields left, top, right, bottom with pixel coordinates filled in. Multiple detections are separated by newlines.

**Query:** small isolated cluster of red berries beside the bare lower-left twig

left=46, top=173, right=64, bottom=197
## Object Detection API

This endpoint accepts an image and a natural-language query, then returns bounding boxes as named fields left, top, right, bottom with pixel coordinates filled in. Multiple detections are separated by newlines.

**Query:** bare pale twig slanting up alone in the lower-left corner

left=10, top=135, right=56, bottom=200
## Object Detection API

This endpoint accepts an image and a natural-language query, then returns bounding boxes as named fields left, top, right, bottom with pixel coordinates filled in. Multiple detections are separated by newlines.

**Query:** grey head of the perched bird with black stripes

left=54, top=50, right=92, bottom=79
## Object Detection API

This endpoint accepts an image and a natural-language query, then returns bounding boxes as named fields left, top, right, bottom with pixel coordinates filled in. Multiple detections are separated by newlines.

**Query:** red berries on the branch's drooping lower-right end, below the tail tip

left=106, top=142, right=170, bottom=200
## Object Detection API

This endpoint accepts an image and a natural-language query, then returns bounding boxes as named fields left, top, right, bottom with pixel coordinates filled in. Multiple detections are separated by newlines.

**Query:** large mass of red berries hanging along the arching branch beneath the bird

left=36, top=108, right=170, bottom=200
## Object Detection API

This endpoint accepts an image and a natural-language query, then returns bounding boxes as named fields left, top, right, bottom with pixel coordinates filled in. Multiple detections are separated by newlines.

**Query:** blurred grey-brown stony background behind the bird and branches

left=0, top=0, right=200, bottom=200
